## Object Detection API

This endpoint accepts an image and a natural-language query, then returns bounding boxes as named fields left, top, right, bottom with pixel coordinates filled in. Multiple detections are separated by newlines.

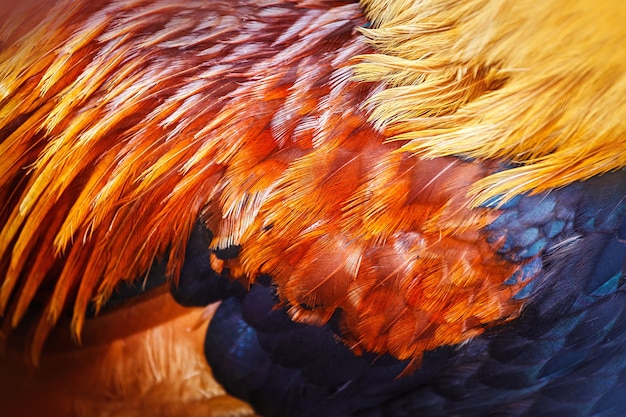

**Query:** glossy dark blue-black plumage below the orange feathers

left=180, top=170, right=626, bottom=417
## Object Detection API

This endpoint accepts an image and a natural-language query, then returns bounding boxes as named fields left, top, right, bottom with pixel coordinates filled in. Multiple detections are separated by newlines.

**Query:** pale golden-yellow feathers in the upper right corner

left=355, top=0, right=626, bottom=204
